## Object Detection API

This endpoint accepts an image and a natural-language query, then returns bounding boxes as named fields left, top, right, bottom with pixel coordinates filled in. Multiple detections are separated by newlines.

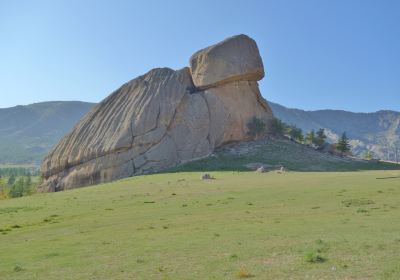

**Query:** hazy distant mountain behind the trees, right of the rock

left=268, top=102, right=400, bottom=161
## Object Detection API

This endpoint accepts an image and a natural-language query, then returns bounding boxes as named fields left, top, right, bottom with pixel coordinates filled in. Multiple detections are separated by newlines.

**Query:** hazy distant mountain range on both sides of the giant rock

left=0, top=101, right=400, bottom=164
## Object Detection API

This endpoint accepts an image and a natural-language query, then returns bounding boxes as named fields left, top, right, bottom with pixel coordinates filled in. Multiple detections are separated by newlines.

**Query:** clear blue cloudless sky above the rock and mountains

left=0, top=0, right=400, bottom=112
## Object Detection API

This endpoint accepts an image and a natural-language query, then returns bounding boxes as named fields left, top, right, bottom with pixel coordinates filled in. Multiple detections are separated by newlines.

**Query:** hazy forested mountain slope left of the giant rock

left=0, top=101, right=95, bottom=164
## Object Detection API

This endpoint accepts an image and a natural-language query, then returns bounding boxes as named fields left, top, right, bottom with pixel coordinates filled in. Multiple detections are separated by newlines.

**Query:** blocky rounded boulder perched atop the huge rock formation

left=190, top=35, right=264, bottom=89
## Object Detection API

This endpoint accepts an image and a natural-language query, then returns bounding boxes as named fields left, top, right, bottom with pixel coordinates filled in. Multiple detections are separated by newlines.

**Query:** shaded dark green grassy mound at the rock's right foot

left=168, top=139, right=400, bottom=172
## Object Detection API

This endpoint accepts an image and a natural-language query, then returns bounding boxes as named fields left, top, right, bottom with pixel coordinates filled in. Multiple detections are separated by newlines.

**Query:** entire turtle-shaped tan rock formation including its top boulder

left=40, top=35, right=272, bottom=191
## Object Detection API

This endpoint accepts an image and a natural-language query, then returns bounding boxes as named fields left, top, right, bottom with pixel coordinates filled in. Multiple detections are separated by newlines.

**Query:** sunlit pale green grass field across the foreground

left=0, top=171, right=400, bottom=279
